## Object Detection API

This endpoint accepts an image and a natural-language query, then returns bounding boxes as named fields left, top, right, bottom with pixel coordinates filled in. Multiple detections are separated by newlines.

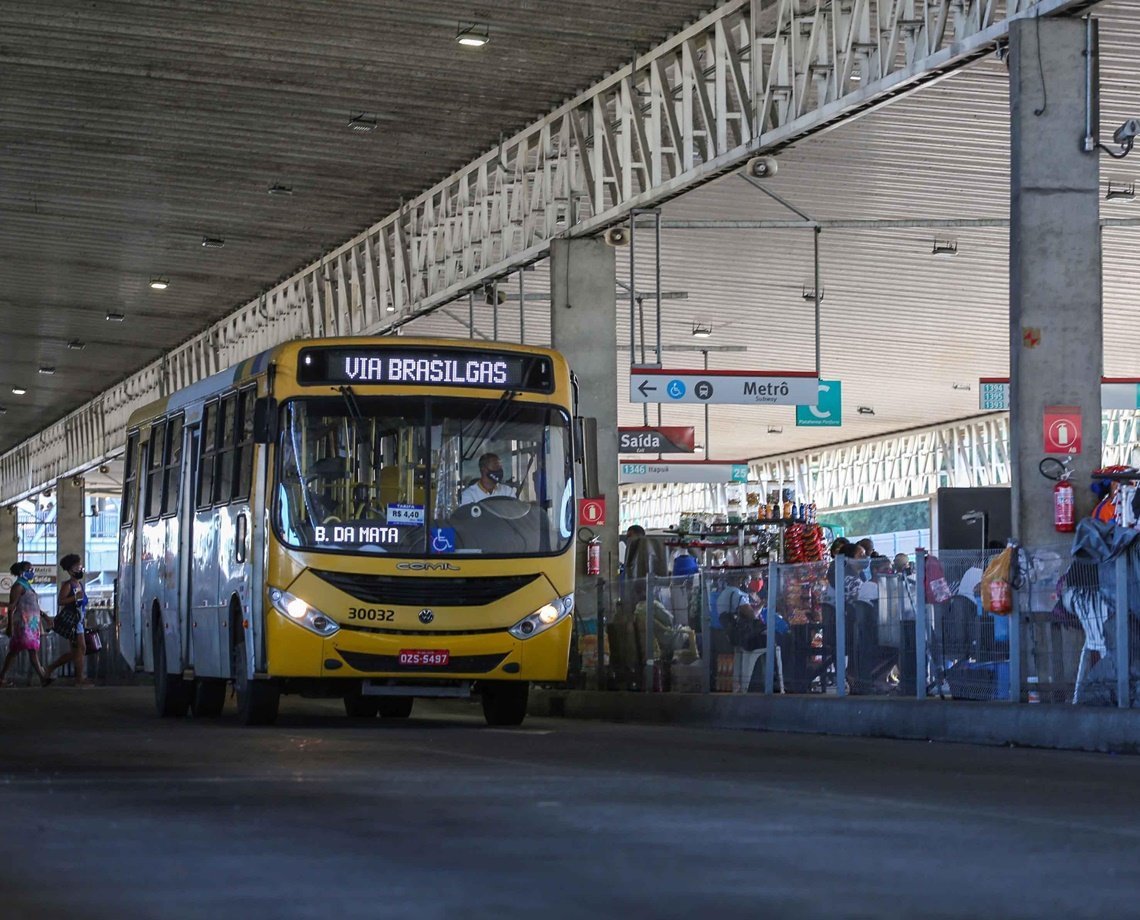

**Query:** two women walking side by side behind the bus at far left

left=0, top=553, right=93, bottom=687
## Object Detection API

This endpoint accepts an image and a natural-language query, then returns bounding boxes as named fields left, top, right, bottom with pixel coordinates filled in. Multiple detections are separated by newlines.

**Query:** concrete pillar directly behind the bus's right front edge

left=551, top=239, right=618, bottom=617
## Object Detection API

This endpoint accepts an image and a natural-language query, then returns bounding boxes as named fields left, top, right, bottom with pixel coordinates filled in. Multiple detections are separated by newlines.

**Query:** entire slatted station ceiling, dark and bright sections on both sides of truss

left=0, top=0, right=1140, bottom=467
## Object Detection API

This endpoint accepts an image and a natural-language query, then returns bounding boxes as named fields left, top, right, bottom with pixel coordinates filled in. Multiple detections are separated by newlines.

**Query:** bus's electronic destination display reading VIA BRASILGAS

left=296, top=345, right=554, bottom=393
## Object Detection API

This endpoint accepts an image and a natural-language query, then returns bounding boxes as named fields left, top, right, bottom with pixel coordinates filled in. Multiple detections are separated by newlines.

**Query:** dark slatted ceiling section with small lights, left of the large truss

left=0, top=0, right=709, bottom=450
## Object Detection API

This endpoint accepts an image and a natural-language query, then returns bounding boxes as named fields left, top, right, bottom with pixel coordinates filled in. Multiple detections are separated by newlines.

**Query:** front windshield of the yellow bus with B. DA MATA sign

left=274, top=388, right=573, bottom=557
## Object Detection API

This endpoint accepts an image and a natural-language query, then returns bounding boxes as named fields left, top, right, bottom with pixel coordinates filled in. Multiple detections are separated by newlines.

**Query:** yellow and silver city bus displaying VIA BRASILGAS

left=117, top=337, right=575, bottom=725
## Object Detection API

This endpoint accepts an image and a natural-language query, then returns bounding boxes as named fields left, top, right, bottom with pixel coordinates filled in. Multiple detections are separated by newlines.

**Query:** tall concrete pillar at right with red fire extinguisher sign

left=1009, top=18, right=1104, bottom=547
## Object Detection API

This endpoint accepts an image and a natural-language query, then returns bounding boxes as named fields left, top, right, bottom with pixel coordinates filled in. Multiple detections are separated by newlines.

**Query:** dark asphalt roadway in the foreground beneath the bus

left=0, top=685, right=1140, bottom=920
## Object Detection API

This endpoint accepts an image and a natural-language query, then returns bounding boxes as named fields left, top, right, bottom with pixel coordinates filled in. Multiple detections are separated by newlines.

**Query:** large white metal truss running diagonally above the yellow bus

left=0, top=0, right=1088, bottom=502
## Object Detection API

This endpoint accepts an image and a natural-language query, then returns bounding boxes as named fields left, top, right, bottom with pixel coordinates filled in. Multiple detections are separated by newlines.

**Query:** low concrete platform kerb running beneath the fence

left=530, top=689, right=1140, bottom=754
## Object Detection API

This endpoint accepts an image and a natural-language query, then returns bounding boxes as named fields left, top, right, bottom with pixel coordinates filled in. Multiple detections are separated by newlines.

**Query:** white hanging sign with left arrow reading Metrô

left=629, top=367, right=820, bottom=406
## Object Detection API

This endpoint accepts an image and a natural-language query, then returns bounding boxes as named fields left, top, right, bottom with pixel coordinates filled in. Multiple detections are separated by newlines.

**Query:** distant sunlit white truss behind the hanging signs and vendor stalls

left=621, top=412, right=1140, bottom=528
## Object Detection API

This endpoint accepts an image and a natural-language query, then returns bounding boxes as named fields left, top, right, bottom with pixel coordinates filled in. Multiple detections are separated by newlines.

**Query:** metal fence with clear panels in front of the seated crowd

left=595, top=540, right=1140, bottom=707
